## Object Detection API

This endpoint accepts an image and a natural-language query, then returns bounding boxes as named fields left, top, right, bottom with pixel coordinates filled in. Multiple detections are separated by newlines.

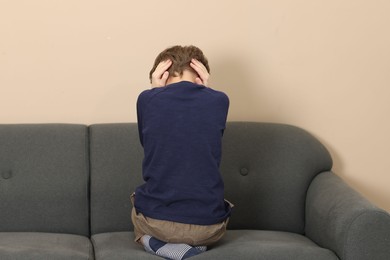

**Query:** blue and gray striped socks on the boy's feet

left=141, top=235, right=207, bottom=260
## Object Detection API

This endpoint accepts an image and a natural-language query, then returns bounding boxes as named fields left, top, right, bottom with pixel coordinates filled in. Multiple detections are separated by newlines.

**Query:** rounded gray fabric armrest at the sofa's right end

left=305, top=172, right=390, bottom=260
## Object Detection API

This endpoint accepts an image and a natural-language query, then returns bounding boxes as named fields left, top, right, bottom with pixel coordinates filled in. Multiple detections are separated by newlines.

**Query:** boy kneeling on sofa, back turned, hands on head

left=132, top=46, right=232, bottom=259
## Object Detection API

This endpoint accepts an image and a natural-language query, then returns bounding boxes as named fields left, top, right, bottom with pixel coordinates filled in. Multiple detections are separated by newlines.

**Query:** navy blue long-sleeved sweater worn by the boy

left=135, top=81, right=231, bottom=225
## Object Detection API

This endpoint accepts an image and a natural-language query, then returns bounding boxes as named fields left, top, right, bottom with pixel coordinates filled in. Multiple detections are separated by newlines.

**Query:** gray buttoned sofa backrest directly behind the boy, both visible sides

left=90, top=122, right=332, bottom=234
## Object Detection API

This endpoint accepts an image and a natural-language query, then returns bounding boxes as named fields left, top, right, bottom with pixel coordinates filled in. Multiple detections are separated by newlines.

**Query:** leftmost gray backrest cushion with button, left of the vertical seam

left=0, top=124, right=89, bottom=236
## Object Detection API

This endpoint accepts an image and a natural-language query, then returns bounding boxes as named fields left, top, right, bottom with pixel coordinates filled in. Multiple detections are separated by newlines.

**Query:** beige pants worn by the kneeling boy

left=131, top=194, right=233, bottom=246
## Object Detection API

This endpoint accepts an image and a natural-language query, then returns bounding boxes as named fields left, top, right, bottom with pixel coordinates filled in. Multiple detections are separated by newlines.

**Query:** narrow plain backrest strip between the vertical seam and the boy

left=89, top=123, right=143, bottom=234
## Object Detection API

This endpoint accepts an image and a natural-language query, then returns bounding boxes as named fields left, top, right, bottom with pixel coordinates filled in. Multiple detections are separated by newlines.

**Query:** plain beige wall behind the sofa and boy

left=0, top=0, right=390, bottom=211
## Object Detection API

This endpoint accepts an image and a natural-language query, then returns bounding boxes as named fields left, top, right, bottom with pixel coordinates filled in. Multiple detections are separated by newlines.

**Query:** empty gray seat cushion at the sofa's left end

left=0, top=232, right=93, bottom=260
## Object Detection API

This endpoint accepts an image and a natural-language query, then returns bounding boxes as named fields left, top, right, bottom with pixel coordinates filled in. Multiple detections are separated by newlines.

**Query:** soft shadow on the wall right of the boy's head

left=211, top=57, right=261, bottom=121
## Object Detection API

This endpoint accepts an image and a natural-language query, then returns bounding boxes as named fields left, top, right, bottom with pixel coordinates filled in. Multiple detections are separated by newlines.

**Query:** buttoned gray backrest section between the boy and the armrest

left=221, top=122, right=332, bottom=234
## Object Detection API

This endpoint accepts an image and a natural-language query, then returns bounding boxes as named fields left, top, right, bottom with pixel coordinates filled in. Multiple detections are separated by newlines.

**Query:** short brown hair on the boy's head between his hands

left=149, top=45, right=210, bottom=81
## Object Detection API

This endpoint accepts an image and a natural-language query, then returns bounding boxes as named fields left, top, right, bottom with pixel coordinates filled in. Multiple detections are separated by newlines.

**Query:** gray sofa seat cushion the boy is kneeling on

left=92, top=230, right=338, bottom=260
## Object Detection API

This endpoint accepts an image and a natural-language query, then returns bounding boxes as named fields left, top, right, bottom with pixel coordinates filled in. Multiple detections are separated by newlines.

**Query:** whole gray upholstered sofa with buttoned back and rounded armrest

left=0, top=122, right=390, bottom=260
